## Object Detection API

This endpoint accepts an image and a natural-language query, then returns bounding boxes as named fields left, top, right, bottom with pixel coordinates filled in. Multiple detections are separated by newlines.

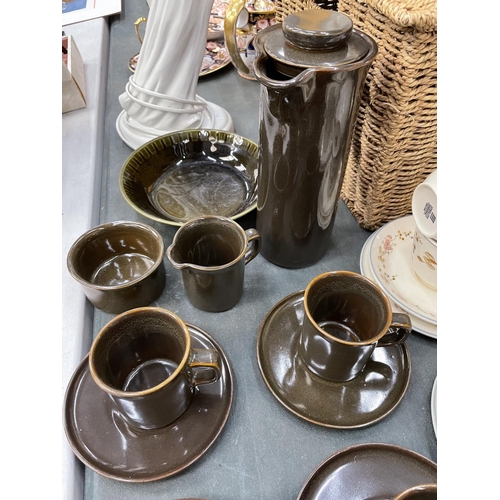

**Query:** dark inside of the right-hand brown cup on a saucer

left=305, top=273, right=390, bottom=342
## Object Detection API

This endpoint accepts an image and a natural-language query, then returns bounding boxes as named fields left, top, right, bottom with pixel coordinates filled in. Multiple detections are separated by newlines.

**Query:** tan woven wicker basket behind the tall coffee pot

left=276, top=0, right=437, bottom=230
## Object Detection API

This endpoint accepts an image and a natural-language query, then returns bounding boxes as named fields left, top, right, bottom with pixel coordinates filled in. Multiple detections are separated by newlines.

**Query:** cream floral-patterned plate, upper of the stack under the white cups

left=369, top=215, right=437, bottom=325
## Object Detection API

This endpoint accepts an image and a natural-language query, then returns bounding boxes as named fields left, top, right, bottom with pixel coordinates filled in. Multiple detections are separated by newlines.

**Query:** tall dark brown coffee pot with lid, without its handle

left=254, top=9, right=378, bottom=268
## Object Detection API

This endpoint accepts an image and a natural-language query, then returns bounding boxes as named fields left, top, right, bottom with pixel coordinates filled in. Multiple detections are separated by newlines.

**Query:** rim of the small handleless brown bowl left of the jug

left=66, top=220, right=165, bottom=290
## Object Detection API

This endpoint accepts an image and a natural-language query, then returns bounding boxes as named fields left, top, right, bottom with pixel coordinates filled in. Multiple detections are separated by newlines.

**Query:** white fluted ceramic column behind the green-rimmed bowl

left=116, top=0, right=234, bottom=149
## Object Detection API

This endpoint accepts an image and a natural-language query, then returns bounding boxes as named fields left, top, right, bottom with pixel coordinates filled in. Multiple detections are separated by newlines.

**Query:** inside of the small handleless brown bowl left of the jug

left=68, top=223, right=164, bottom=287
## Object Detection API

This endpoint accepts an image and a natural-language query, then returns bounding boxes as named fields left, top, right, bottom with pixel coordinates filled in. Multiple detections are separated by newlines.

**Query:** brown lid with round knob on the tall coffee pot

left=264, top=9, right=370, bottom=74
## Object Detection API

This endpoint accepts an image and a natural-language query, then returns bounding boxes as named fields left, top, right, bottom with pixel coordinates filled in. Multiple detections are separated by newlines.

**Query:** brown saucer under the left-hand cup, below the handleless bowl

left=64, top=324, right=233, bottom=483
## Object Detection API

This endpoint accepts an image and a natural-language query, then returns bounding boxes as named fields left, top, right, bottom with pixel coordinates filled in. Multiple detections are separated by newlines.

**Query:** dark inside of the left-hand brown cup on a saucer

left=91, top=308, right=189, bottom=392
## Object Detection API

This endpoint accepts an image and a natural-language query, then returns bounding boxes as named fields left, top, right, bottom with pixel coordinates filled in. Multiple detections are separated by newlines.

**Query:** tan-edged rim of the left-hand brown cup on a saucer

left=89, top=307, right=191, bottom=398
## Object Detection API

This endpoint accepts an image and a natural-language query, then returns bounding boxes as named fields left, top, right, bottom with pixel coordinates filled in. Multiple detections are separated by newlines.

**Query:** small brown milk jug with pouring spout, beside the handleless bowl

left=167, top=215, right=260, bottom=312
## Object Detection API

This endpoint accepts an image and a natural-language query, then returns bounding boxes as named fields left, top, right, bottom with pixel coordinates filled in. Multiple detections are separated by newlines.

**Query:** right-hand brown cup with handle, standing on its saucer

left=298, top=271, right=411, bottom=382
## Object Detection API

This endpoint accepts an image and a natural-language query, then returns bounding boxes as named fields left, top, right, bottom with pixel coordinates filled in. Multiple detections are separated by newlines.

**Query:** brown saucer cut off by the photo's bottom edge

left=297, top=443, right=437, bottom=500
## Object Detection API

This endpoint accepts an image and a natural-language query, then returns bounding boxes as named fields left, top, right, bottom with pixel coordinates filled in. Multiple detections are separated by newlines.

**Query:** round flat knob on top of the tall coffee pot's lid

left=282, top=9, right=353, bottom=50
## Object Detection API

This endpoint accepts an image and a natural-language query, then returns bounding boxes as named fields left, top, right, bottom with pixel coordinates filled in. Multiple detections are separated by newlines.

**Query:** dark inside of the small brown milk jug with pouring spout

left=171, top=218, right=245, bottom=267
